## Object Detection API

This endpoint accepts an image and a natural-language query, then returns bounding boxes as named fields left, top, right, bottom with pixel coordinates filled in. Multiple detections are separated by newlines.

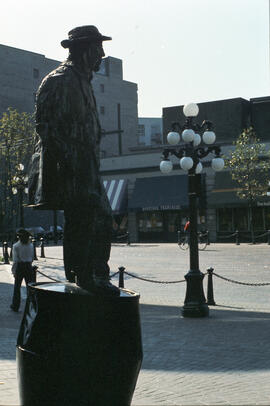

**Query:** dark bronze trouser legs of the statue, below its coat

left=64, top=204, right=112, bottom=282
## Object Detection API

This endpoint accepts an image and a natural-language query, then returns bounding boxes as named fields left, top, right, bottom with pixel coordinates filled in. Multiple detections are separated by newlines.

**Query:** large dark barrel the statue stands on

left=17, top=283, right=142, bottom=406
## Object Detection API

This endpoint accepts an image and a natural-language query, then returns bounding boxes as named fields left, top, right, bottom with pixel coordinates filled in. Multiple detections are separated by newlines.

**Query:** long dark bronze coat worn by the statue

left=29, top=61, right=110, bottom=212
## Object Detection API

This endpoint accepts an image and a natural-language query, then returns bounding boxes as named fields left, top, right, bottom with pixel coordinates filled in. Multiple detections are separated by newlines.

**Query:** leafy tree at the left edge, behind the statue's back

left=0, top=107, right=35, bottom=232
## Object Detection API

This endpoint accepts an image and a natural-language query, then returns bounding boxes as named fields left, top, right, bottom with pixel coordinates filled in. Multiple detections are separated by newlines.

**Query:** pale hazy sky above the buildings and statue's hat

left=0, top=0, right=270, bottom=117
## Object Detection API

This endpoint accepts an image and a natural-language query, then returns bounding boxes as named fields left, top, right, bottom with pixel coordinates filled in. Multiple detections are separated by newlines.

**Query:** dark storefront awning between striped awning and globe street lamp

left=128, top=175, right=188, bottom=211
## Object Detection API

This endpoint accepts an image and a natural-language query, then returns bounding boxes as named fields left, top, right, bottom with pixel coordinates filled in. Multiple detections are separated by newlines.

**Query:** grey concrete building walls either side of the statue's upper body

left=0, top=45, right=138, bottom=156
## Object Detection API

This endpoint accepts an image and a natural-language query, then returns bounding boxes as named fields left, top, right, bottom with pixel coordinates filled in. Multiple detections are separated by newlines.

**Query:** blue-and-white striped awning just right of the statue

left=103, top=179, right=127, bottom=213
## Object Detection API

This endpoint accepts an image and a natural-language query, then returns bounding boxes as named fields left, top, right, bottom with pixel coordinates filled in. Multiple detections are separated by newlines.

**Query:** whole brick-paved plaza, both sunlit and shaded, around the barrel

left=0, top=244, right=270, bottom=406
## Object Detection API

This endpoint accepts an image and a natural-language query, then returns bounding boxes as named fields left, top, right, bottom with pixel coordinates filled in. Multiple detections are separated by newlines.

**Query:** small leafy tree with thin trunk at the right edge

left=226, top=126, right=270, bottom=241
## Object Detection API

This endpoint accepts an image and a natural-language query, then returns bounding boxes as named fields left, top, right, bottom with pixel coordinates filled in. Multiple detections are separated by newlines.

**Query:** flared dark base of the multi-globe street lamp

left=182, top=270, right=209, bottom=317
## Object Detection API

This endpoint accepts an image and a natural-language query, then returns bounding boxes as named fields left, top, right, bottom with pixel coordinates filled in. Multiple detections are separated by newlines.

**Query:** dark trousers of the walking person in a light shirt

left=12, top=262, right=36, bottom=310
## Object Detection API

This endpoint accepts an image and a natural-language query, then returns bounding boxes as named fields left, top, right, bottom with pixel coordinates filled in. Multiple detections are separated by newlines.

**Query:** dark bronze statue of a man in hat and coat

left=29, top=25, right=119, bottom=294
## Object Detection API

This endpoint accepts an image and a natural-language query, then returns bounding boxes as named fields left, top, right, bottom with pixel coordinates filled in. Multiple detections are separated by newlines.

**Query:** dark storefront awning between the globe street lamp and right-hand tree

left=208, top=171, right=247, bottom=208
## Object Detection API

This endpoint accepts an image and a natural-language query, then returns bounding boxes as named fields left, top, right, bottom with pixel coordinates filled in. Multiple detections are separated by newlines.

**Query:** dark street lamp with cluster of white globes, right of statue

left=160, top=103, right=224, bottom=317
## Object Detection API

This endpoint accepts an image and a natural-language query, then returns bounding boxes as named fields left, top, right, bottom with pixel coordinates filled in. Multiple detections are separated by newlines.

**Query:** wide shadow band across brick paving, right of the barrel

left=141, top=304, right=270, bottom=372
